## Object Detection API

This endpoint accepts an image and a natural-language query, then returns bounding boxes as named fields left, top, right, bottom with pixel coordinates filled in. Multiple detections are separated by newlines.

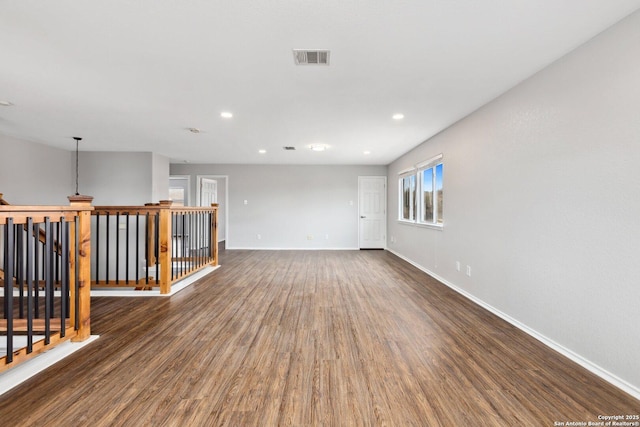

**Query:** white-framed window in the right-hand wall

left=398, top=154, right=444, bottom=226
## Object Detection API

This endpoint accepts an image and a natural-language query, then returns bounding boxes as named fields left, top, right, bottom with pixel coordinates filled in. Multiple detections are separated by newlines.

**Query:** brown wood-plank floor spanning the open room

left=0, top=251, right=640, bottom=426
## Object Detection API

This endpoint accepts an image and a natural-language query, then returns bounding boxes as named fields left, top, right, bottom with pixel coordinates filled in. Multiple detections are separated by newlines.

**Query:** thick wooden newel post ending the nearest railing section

left=69, top=195, right=93, bottom=341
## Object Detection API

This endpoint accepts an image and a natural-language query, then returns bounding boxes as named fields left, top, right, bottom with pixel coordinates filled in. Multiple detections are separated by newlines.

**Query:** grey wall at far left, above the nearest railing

left=0, top=135, right=75, bottom=205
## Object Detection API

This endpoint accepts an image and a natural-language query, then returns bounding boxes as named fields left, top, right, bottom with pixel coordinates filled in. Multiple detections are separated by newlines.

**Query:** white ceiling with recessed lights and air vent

left=0, top=0, right=640, bottom=164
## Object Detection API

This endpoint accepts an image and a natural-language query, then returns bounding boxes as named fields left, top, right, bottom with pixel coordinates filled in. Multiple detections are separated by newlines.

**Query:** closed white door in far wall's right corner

left=358, top=176, right=387, bottom=249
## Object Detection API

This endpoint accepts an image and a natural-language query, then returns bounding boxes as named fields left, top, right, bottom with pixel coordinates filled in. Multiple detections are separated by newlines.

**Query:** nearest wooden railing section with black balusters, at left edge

left=0, top=196, right=93, bottom=372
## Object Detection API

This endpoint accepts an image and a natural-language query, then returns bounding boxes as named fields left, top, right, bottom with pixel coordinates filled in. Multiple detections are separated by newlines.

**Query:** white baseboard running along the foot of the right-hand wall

left=387, top=249, right=640, bottom=399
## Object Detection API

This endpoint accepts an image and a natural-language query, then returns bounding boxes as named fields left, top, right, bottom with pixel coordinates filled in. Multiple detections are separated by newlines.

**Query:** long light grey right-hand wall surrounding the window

left=388, top=12, right=640, bottom=396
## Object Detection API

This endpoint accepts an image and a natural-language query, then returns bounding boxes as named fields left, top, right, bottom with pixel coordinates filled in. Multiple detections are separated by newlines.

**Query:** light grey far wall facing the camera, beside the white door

left=171, top=164, right=387, bottom=249
